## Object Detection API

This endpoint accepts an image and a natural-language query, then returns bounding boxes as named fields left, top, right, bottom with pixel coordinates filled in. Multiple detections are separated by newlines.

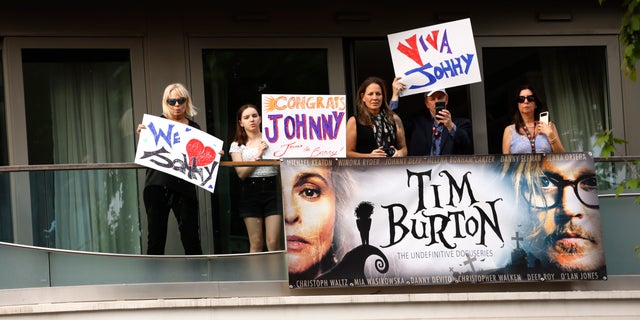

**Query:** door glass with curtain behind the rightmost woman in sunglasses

left=482, top=46, right=611, bottom=156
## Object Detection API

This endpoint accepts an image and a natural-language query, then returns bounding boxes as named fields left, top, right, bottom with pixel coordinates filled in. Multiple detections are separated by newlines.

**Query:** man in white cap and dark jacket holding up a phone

left=389, top=85, right=473, bottom=156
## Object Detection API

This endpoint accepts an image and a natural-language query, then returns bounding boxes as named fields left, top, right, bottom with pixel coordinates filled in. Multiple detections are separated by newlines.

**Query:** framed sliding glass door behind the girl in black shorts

left=191, top=38, right=344, bottom=253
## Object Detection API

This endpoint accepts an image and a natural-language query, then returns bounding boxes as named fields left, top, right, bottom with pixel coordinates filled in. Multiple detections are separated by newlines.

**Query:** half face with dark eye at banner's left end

left=282, top=167, right=335, bottom=273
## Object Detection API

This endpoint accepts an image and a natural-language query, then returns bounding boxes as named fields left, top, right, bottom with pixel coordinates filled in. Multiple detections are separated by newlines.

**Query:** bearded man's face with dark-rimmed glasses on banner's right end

left=529, top=159, right=605, bottom=271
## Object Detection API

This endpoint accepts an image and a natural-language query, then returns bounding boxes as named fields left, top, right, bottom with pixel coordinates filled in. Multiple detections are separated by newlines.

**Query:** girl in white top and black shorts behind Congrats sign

left=229, top=104, right=282, bottom=252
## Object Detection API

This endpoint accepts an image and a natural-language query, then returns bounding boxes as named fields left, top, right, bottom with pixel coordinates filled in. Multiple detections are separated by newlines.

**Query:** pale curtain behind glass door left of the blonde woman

left=24, top=50, right=141, bottom=253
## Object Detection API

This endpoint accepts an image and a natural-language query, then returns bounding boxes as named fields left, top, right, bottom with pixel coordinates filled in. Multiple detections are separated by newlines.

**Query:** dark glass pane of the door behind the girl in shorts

left=203, top=49, right=329, bottom=253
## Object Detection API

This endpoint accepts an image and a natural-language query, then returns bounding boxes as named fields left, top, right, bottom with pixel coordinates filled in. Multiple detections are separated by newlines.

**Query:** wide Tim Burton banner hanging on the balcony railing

left=281, top=153, right=607, bottom=288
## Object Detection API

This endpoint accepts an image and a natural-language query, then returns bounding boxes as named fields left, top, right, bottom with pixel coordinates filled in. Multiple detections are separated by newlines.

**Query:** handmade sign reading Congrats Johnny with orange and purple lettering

left=262, top=94, right=347, bottom=159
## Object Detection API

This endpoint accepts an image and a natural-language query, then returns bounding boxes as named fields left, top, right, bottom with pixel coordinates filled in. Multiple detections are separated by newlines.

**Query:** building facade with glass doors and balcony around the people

left=0, top=0, right=640, bottom=319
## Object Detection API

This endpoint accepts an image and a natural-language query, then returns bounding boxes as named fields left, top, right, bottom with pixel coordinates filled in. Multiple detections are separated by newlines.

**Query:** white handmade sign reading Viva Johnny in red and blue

left=387, top=19, right=482, bottom=96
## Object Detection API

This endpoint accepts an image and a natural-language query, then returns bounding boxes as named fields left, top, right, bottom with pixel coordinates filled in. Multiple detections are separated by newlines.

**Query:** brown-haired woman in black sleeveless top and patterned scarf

left=347, top=77, right=408, bottom=157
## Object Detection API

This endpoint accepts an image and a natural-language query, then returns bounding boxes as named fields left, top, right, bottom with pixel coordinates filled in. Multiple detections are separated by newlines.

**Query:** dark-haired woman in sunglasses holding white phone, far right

left=502, top=85, right=564, bottom=154
